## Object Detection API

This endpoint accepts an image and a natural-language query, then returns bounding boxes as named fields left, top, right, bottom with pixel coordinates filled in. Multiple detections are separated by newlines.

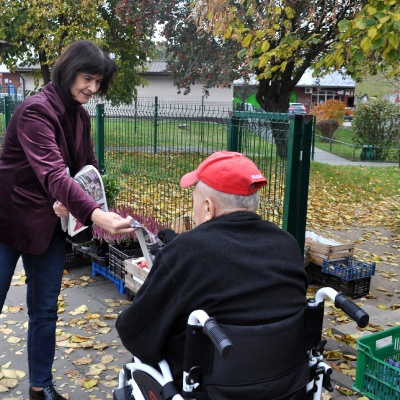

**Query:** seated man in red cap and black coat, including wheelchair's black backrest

left=116, top=151, right=308, bottom=400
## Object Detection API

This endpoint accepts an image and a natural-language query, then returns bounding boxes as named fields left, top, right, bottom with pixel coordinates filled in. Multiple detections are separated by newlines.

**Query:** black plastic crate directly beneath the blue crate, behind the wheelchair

left=306, top=264, right=371, bottom=299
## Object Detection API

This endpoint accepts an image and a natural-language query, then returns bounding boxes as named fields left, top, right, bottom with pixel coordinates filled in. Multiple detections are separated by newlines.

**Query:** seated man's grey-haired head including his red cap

left=180, top=151, right=267, bottom=225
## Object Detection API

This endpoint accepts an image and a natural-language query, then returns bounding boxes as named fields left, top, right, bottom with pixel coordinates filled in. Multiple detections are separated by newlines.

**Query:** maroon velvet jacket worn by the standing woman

left=0, top=83, right=98, bottom=254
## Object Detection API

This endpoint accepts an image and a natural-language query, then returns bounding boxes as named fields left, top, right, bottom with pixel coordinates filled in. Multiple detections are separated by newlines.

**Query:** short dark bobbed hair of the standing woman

left=51, top=40, right=117, bottom=96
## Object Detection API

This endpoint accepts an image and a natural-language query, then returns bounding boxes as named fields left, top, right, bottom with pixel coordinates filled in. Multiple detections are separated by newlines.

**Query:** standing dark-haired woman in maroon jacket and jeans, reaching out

left=0, top=40, right=133, bottom=400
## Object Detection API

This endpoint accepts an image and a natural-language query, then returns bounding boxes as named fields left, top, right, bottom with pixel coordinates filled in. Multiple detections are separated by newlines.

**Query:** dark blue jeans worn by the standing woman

left=0, top=230, right=66, bottom=387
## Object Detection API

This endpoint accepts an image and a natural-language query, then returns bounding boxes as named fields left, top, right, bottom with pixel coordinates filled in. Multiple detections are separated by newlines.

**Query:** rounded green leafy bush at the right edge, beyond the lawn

left=352, top=100, right=400, bottom=161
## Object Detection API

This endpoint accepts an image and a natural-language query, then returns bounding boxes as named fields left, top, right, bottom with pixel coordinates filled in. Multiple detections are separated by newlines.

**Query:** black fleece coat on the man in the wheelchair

left=116, top=212, right=308, bottom=380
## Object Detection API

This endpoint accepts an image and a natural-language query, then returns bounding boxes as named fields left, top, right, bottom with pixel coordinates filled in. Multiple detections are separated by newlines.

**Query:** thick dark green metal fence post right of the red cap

left=282, top=114, right=313, bottom=255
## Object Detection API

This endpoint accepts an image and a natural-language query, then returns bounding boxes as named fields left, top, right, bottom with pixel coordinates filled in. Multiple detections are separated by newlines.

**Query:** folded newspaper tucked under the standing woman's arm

left=61, top=165, right=108, bottom=237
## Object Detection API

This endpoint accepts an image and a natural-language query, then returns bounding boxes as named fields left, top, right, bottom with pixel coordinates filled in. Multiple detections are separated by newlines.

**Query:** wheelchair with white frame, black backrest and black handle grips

left=113, top=287, right=369, bottom=400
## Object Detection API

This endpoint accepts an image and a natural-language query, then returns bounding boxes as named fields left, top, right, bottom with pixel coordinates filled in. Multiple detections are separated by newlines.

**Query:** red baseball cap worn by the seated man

left=180, top=151, right=268, bottom=196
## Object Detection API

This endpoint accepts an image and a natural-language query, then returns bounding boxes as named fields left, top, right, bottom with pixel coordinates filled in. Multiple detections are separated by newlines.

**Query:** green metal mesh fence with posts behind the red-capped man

left=0, top=97, right=314, bottom=252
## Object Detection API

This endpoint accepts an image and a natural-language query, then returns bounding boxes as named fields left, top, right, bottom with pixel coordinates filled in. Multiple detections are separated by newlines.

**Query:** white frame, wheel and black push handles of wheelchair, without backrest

left=113, top=287, right=369, bottom=400
